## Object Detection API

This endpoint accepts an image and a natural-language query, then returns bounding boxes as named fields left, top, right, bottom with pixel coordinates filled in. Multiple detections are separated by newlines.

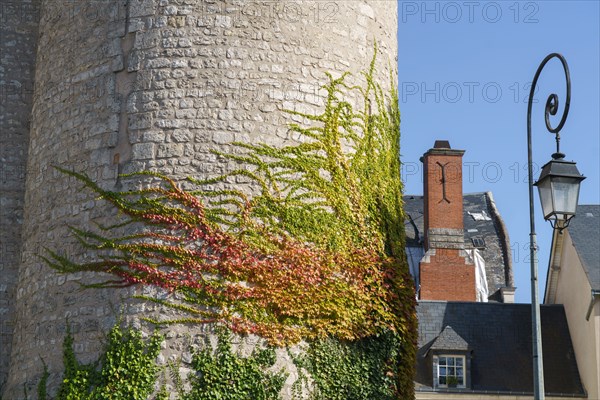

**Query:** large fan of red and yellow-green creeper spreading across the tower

left=44, top=51, right=416, bottom=398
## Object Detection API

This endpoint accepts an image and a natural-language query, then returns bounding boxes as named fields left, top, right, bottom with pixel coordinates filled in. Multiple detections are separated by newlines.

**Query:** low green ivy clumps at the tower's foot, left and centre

left=44, top=324, right=287, bottom=400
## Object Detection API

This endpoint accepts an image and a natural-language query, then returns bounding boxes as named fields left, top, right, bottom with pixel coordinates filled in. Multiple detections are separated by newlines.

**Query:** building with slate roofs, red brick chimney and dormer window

left=404, top=141, right=584, bottom=400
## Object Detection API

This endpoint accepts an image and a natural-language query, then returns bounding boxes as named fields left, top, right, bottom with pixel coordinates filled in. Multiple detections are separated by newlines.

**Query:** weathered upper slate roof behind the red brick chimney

left=403, top=192, right=514, bottom=300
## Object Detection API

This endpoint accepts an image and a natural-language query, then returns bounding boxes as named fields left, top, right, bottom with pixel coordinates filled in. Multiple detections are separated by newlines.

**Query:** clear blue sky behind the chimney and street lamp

left=398, top=0, right=600, bottom=303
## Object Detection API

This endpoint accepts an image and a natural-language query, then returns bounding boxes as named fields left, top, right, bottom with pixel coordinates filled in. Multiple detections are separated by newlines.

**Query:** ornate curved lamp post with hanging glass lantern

left=527, top=53, right=585, bottom=400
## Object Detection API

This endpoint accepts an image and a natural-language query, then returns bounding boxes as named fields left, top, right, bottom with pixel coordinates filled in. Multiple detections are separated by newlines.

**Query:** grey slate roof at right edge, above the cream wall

left=567, top=204, right=600, bottom=290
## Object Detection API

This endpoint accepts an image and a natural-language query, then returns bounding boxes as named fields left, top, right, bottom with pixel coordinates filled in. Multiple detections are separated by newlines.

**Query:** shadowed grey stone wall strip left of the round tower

left=0, top=0, right=39, bottom=392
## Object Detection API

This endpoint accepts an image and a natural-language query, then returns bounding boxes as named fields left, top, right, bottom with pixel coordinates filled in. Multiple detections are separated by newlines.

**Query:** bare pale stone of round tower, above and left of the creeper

left=4, top=0, right=397, bottom=399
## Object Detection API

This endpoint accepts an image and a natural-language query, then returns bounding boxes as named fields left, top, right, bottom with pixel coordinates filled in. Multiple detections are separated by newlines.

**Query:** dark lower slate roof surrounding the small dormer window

left=415, top=301, right=585, bottom=397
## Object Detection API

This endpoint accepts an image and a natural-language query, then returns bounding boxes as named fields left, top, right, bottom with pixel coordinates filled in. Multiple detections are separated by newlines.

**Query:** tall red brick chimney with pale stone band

left=419, top=140, right=477, bottom=301
